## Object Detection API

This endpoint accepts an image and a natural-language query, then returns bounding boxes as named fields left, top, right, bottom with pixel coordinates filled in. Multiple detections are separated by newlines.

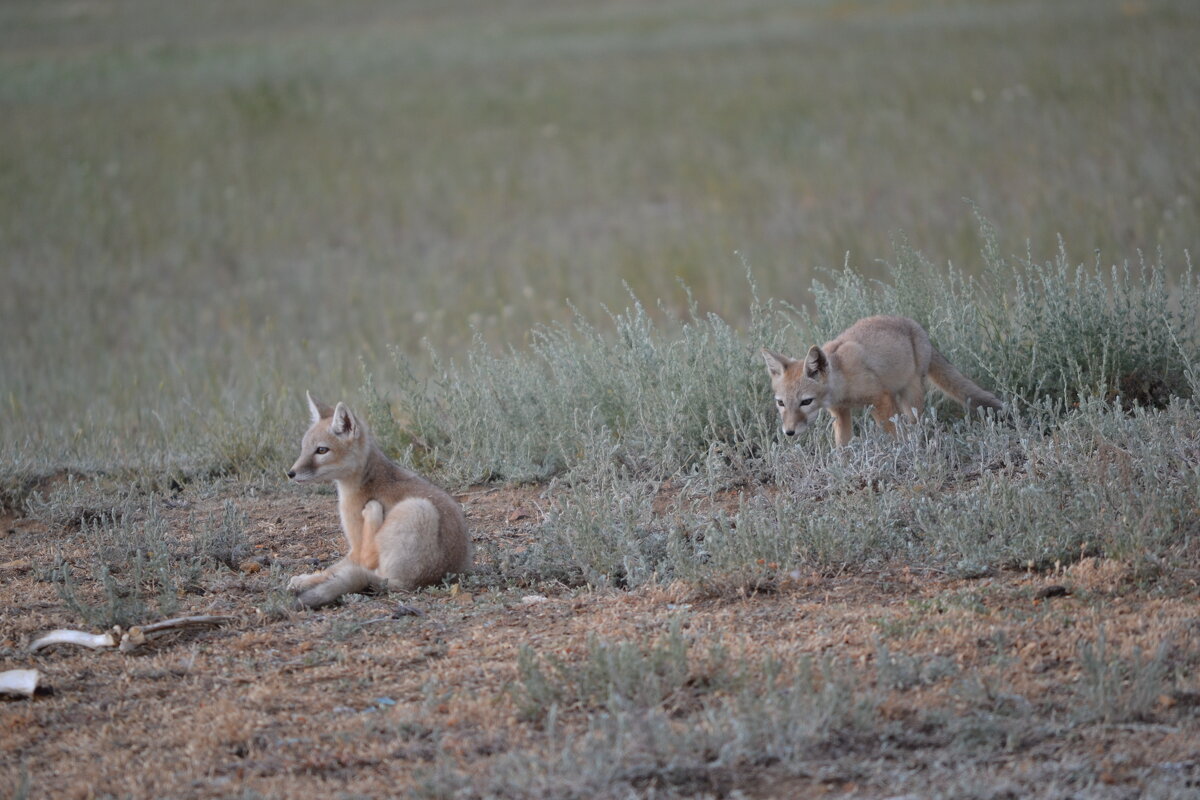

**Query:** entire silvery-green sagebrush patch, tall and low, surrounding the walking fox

left=368, top=223, right=1200, bottom=593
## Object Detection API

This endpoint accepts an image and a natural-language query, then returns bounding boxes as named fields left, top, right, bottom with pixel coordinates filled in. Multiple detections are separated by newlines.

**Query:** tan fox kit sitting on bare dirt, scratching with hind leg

left=288, top=395, right=470, bottom=608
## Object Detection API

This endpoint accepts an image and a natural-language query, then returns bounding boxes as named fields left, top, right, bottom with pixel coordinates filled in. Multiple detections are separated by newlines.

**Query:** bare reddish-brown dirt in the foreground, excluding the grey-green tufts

left=0, top=488, right=1200, bottom=798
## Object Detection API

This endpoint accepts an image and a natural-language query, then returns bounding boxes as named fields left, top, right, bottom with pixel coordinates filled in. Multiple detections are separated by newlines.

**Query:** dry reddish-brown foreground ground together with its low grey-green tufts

left=0, top=487, right=1200, bottom=798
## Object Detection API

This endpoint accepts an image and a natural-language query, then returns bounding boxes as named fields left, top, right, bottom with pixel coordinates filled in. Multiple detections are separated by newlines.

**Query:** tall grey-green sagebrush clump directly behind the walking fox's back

left=805, top=219, right=1200, bottom=408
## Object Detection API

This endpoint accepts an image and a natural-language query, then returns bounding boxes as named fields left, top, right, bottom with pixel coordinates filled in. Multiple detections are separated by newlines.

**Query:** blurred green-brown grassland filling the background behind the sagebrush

left=0, top=0, right=1200, bottom=465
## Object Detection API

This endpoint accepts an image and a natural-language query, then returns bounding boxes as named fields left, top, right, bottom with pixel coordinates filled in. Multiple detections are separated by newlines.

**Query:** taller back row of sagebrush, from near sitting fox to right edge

left=379, top=221, right=1200, bottom=494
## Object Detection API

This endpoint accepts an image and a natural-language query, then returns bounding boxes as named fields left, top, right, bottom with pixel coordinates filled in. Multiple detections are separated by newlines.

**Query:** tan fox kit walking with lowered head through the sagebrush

left=762, top=317, right=1004, bottom=447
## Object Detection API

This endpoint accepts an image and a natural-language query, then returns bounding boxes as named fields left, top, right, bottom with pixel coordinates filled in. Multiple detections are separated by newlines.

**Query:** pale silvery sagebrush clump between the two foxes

left=372, top=281, right=790, bottom=482
